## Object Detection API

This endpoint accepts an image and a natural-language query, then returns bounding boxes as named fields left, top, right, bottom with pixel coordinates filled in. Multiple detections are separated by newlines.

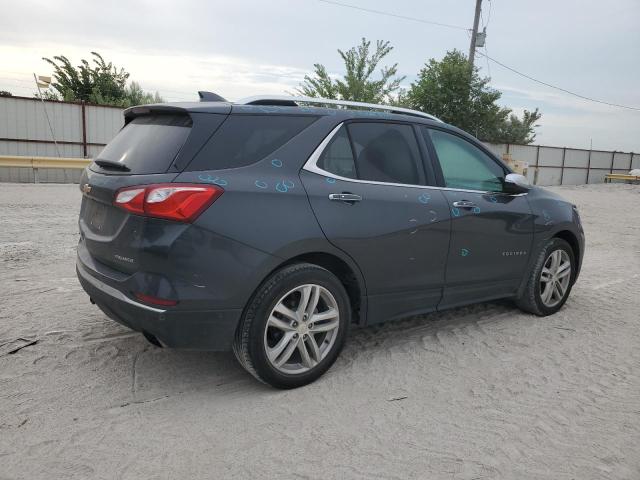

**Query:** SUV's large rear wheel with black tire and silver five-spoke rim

left=233, top=263, right=351, bottom=389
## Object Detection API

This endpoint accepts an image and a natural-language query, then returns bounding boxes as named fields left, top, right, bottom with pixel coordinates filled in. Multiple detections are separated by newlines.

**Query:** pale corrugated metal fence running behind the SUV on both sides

left=0, top=97, right=640, bottom=185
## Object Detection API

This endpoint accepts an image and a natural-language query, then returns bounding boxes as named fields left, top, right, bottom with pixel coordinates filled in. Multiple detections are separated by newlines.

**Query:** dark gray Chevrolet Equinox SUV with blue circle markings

left=77, top=97, right=584, bottom=388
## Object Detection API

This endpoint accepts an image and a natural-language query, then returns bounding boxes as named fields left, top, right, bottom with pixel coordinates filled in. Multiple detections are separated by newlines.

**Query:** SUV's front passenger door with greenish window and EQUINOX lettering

left=421, top=127, right=533, bottom=308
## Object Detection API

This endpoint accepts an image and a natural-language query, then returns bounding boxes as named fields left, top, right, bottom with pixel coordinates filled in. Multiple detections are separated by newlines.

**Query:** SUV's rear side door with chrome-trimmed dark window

left=301, top=121, right=450, bottom=323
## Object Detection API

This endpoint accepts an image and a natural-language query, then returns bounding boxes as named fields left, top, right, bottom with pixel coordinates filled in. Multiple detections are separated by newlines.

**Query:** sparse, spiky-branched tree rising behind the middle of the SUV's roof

left=297, top=38, right=405, bottom=103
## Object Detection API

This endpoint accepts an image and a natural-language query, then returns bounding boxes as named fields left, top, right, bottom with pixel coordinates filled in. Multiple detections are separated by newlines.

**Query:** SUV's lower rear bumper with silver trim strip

left=76, top=257, right=242, bottom=351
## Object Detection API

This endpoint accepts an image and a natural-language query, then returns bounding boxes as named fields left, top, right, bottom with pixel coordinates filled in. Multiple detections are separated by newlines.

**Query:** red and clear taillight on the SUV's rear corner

left=113, top=183, right=224, bottom=222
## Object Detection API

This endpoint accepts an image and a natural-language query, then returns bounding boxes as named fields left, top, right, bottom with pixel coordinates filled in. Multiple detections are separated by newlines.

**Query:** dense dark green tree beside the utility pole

left=401, top=50, right=542, bottom=144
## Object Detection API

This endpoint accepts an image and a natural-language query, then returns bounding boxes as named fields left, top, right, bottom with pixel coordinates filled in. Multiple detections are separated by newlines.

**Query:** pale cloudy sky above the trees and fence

left=0, top=0, right=640, bottom=152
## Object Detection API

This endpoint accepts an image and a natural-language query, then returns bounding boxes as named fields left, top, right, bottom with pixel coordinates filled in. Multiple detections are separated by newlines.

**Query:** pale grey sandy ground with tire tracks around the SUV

left=0, top=184, right=640, bottom=480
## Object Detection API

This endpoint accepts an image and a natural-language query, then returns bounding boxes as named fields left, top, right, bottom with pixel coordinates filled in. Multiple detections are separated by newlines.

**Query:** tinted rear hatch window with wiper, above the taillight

left=95, top=115, right=192, bottom=174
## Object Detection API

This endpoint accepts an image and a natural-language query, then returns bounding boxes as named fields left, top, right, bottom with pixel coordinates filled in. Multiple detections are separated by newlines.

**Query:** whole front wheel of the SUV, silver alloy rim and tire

left=516, top=238, right=576, bottom=317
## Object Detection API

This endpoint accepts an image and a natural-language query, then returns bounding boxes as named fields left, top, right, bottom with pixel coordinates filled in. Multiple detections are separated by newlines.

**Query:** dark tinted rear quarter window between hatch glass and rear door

left=187, top=115, right=317, bottom=171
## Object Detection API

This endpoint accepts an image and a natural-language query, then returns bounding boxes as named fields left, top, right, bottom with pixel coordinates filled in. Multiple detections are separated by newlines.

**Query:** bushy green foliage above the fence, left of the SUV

left=42, top=52, right=162, bottom=107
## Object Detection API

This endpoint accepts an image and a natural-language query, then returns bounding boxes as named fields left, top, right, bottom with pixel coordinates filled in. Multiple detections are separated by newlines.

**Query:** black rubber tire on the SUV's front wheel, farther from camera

left=516, top=238, right=576, bottom=317
